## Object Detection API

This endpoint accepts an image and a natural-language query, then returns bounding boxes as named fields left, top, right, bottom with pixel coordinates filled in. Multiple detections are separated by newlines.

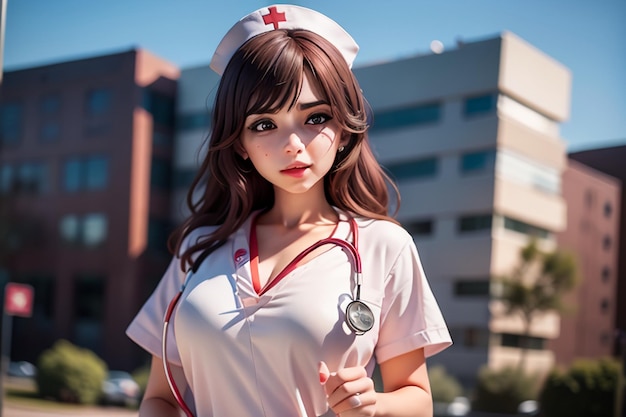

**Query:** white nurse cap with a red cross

left=210, top=4, right=359, bottom=75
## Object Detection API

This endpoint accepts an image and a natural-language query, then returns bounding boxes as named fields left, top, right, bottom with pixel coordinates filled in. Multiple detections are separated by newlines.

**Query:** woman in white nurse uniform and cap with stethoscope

left=127, top=5, right=451, bottom=417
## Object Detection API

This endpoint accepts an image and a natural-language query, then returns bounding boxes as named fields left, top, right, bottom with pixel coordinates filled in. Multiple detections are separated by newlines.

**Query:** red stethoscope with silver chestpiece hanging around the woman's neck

left=161, top=213, right=374, bottom=417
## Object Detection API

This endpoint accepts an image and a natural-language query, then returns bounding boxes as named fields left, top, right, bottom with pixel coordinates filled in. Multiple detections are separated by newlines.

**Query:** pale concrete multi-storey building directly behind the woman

left=174, top=33, right=571, bottom=382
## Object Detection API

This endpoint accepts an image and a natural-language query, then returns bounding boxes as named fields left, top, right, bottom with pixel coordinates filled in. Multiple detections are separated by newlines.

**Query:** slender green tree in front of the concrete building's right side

left=500, top=240, right=578, bottom=369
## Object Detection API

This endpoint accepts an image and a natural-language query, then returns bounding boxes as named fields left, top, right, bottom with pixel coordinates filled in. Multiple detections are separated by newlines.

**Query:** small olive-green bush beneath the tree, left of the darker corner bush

left=472, top=367, right=538, bottom=414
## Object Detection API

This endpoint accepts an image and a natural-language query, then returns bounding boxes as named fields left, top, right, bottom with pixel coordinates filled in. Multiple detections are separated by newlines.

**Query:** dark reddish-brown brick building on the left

left=0, top=50, right=179, bottom=368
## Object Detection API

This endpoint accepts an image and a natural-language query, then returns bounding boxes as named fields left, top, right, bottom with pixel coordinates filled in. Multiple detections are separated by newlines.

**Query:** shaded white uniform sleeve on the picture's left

left=126, top=257, right=185, bottom=366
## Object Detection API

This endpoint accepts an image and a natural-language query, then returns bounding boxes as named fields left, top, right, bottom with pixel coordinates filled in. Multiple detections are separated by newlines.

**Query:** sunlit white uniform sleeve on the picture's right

left=376, top=239, right=452, bottom=362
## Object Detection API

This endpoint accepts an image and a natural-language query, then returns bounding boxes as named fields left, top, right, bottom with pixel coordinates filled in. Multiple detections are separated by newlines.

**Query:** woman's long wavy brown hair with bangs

left=168, top=30, right=400, bottom=270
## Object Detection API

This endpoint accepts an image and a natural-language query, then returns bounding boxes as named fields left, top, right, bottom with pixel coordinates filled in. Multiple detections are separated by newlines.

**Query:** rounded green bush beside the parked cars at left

left=37, top=340, right=108, bottom=404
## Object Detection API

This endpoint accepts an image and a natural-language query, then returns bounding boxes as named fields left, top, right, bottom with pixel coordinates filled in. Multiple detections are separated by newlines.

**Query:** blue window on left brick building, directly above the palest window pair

left=63, top=156, right=109, bottom=192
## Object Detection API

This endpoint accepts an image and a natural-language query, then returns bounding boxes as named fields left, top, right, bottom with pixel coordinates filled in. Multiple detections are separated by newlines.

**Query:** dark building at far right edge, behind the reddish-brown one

left=570, top=145, right=626, bottom=357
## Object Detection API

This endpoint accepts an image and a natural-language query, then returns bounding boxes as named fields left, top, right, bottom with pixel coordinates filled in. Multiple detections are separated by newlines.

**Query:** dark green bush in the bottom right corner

left=539, top=358, right=620, bottom=417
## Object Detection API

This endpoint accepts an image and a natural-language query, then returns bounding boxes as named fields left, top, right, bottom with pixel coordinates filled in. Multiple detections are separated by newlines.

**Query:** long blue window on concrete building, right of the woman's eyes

left=371, top=103, right=441, bottom=130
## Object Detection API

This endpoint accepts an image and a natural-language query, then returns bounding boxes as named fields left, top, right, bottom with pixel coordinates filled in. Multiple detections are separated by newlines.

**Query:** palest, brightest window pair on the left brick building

left=59, top=213, right=108, bottom=247
